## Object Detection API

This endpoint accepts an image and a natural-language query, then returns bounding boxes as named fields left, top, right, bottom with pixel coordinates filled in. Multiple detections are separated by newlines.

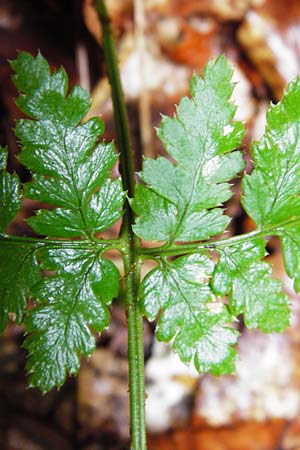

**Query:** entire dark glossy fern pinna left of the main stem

left=0, top=52, right=125, bottom=391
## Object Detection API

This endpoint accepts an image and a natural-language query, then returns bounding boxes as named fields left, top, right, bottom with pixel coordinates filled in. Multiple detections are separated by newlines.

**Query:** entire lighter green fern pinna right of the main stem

left=137, top=57, right=300, bottom=374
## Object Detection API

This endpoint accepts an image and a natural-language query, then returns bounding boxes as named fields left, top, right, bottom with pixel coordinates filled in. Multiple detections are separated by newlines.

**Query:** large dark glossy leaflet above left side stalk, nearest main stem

left=11, top=52, right=125, bottom=239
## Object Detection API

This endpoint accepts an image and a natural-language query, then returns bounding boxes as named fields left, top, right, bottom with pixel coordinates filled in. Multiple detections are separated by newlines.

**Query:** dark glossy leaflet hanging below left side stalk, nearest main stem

left=24, top=249, right=120, bottom=392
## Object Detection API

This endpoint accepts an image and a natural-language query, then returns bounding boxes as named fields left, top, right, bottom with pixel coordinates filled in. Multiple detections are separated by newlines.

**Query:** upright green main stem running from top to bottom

left=96, top=0, right=147, bottom=450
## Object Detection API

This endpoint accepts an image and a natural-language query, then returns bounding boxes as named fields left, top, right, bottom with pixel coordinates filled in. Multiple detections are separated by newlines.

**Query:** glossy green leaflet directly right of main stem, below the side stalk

left=140, top=254, right=239, bottom=375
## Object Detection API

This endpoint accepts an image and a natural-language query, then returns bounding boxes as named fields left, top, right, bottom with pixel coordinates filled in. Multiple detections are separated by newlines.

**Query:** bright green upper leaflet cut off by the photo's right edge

left=242, top=77, right=300, bottom=291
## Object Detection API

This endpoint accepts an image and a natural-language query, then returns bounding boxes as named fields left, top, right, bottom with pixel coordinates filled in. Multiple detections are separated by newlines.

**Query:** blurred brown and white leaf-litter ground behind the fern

left=0, top=0, right=300, bottom=450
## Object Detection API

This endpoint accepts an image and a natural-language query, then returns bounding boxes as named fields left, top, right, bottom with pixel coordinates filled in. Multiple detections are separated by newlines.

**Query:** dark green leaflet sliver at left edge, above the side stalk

left=0, top=147, right=22, bottom=233
